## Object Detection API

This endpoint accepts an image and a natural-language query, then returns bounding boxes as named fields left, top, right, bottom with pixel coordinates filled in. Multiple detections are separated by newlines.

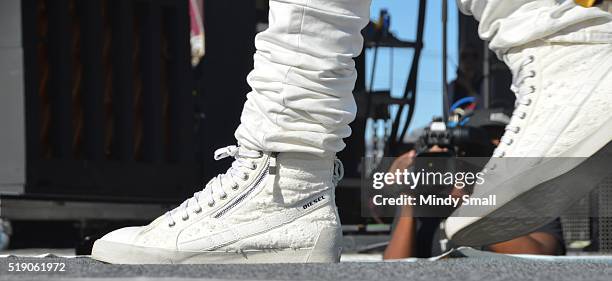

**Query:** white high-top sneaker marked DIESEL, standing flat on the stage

left=91, top=146, right=342, bottom=264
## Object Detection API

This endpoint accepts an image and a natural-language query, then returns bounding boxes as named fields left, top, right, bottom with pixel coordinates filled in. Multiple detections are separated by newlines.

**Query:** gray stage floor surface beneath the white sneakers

left=0, top=248, right=612, bottom=281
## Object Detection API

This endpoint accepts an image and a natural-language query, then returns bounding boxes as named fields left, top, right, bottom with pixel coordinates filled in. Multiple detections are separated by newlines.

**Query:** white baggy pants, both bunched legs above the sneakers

left=235, top=0, right=612, bottom=155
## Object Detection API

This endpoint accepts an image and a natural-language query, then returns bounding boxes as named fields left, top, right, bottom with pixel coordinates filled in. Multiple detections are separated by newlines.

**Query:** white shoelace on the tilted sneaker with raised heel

left=493, top=56, right=536, bottom=157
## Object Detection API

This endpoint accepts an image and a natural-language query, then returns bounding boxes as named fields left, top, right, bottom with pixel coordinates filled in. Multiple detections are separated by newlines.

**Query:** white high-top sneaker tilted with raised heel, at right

left=444, top=42, right=612, bottom=246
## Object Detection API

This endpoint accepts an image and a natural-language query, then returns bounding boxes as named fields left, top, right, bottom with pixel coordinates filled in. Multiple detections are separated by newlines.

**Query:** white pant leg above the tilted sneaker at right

left=457, top=0, right=612, bottom=55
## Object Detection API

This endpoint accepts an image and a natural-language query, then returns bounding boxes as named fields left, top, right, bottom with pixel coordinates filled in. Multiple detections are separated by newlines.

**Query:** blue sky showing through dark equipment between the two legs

left=366, top=0, right=458, bottom=130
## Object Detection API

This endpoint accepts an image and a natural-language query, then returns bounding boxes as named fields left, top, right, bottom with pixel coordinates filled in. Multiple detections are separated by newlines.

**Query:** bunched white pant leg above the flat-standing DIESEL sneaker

left=235, top=0, right=370, bottom=155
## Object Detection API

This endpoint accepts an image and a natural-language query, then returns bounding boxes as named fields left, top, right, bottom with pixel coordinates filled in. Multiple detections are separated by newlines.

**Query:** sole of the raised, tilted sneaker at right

left=445, top=117, right=612, bottom=246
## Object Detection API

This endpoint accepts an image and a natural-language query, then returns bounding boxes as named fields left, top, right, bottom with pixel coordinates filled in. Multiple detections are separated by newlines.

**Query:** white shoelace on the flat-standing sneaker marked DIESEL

left=166, top=145, right=263, bottom=227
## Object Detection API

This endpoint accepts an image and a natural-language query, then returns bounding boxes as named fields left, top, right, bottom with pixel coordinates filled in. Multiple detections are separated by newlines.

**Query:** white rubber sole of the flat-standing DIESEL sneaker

left=91, top=225, right=341, bottom=264
